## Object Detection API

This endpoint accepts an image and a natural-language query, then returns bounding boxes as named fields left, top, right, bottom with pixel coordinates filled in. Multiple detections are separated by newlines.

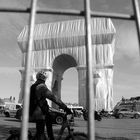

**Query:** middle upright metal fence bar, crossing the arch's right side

left=84, top=0, right=95, bottom=140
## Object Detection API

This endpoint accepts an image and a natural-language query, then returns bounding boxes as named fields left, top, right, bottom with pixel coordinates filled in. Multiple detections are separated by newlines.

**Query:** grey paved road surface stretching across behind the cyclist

left=0, top=117, right=140, bottom=140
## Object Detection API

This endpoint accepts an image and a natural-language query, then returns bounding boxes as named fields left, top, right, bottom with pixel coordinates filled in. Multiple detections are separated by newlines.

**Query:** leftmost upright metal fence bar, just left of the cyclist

left=21, top=0, right=37, bottom=140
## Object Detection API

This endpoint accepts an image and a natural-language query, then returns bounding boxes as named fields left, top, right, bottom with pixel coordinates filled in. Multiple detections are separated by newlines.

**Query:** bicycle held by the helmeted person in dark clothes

left=7, top=113, right=88, bottom=140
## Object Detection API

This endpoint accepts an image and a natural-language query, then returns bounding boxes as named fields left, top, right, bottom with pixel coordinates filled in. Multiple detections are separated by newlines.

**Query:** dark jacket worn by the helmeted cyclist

left=29, top=80, right=66, bottom=120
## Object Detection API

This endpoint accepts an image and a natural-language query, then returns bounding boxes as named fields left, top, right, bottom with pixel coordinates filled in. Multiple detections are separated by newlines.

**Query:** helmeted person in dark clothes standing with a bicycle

left=29, top=71, right=71, bottom=140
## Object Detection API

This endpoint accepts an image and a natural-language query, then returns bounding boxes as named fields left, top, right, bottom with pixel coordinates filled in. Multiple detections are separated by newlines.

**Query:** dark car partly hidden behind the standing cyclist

left=15, top=107, right=65, bottom=124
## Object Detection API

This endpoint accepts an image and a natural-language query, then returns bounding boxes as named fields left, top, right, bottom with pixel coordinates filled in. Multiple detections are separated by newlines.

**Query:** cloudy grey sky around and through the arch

left=0, top=0, right=140, bottom=104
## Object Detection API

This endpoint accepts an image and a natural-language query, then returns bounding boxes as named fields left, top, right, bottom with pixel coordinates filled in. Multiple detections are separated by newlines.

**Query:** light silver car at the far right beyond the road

left=114, top=108, right=140, bottom=119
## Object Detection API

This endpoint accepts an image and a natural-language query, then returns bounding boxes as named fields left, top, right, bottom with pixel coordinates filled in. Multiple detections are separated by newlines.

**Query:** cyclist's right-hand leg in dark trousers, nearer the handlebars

left=46, top=113, right=54, bottom=140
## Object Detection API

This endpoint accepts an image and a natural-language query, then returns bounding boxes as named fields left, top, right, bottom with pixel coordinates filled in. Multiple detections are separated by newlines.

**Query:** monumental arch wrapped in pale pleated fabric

left=18, top=18, right=116, bottom=110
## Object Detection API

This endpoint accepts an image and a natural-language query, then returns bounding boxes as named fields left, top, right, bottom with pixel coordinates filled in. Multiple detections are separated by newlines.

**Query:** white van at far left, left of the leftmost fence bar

left=4, top=102, right=21, bottom=117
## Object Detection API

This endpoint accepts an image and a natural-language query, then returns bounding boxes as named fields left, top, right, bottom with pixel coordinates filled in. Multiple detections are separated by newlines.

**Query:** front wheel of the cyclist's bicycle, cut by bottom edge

left=65, top=132, right=88, bottom=140
